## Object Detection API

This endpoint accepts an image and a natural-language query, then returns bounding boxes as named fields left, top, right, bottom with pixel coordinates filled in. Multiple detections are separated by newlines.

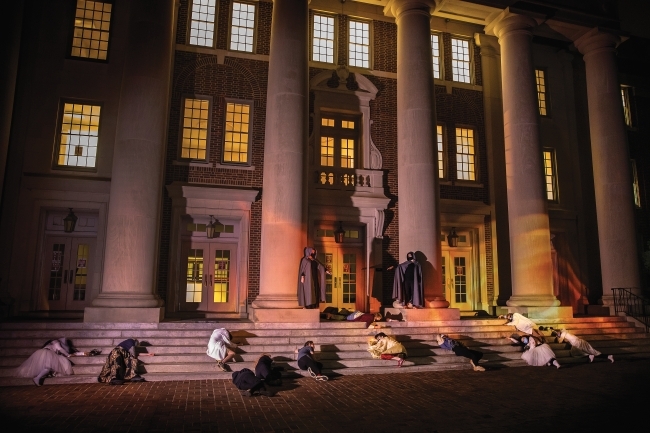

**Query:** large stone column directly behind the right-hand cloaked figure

left=384, top=0, right=449, bottom=316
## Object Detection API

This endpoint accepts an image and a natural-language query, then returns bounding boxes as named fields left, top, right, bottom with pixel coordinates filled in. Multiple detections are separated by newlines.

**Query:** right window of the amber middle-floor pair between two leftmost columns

left=223, top=102, right=251, bottom=164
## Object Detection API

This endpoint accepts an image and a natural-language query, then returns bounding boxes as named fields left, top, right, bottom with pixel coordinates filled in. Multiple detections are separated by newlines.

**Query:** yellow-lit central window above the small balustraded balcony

left=320, top=113, right=359, bottom=168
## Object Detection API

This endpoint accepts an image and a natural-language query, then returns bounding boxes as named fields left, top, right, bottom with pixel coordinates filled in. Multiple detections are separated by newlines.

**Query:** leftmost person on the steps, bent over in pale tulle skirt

left=16, top=337, right=88, bottom=386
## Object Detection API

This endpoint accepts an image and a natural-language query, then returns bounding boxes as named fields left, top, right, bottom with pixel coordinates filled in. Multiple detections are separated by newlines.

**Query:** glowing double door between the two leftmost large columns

left=180, top=241, right=237, bottom=313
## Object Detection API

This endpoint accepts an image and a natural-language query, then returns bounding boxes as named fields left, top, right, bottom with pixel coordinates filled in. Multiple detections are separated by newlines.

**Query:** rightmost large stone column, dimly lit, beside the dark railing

left=575, top=29, right=640, bottom=305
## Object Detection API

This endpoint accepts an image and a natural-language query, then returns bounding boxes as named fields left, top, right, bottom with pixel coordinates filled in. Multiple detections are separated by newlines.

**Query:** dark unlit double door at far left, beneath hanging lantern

left=41, top=236, right=96, bottom=311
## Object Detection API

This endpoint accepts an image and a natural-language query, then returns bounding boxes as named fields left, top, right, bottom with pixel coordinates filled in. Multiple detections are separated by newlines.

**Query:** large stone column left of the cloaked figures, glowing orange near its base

left=251, top=0, right=308, bottom=321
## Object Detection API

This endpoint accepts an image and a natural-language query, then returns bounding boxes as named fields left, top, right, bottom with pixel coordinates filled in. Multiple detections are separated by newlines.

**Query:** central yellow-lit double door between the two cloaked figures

left=318, top=246, right=366, bottom=311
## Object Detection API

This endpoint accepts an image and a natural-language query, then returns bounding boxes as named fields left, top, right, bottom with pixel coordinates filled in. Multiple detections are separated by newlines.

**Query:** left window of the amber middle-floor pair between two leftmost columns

left=181, top=98, right=210, bottom=161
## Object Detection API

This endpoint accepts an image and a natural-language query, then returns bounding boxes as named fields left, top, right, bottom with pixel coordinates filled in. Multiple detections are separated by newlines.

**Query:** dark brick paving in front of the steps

left=0, top=359, right=650, bottom=433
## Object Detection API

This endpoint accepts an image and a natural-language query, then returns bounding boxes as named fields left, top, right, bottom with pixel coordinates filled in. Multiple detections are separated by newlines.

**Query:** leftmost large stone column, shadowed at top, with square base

left=84, top=0, right=174, bottom=322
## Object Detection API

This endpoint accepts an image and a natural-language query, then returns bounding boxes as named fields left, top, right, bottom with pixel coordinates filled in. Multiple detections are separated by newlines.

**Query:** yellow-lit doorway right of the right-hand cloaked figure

left=442, top=248, right=474, bottom=311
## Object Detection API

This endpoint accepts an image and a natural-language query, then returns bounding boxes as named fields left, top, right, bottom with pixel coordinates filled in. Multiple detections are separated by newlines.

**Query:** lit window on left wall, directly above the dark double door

left=56, top=102, right=101, bottom=168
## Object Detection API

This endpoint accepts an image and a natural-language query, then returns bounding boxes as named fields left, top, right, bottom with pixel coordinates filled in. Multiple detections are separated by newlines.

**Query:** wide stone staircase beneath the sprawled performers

left=0, top=317, right=650, bottom=386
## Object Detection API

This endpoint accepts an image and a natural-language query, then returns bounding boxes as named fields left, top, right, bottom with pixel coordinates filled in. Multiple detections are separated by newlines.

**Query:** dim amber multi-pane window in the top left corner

left=70, top=0, right=113, bottom=60
